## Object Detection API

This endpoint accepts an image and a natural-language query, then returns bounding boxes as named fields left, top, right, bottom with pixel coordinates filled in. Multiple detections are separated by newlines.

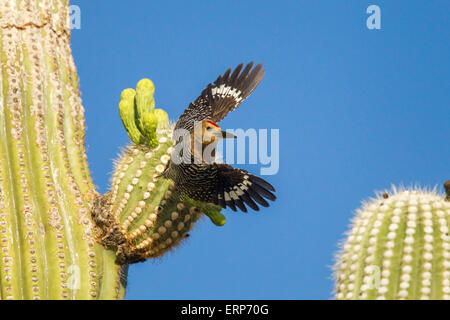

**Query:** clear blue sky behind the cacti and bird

left=71, top=0, right=450, bottom=299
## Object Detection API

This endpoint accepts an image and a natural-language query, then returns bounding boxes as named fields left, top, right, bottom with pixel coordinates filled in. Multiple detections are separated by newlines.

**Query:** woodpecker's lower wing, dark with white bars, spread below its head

left=183, top=163, right=276, bottom=212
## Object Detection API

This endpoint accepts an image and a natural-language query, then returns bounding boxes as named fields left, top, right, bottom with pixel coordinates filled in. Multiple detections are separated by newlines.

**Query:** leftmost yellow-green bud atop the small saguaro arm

left=119, top=89, right=144, bottom=144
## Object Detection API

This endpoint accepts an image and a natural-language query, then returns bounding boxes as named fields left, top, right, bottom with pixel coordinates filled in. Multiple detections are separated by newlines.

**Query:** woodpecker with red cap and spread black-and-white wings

left=162, top=62, right=276, bottom=212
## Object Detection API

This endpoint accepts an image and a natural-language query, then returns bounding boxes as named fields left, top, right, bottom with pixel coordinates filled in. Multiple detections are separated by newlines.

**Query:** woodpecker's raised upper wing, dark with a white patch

left=175, top=62, right=265, bottom=131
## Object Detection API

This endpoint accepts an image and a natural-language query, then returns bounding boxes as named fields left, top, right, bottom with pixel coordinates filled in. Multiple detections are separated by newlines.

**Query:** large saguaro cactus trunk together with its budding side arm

left=0, top=0, right=225, bottom=299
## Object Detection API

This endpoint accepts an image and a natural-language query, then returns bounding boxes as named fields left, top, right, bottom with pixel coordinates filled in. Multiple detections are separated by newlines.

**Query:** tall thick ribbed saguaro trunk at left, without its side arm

left=0, top=0, right=124, bottom=299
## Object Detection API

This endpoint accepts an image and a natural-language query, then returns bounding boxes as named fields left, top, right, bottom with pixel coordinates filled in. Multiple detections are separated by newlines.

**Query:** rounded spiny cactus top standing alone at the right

left=335, top=188, right=450, bottom=300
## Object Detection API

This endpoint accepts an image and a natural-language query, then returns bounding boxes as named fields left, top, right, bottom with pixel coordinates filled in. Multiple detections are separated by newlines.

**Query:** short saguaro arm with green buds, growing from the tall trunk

left=92, top=79, right=225, bottom=264
